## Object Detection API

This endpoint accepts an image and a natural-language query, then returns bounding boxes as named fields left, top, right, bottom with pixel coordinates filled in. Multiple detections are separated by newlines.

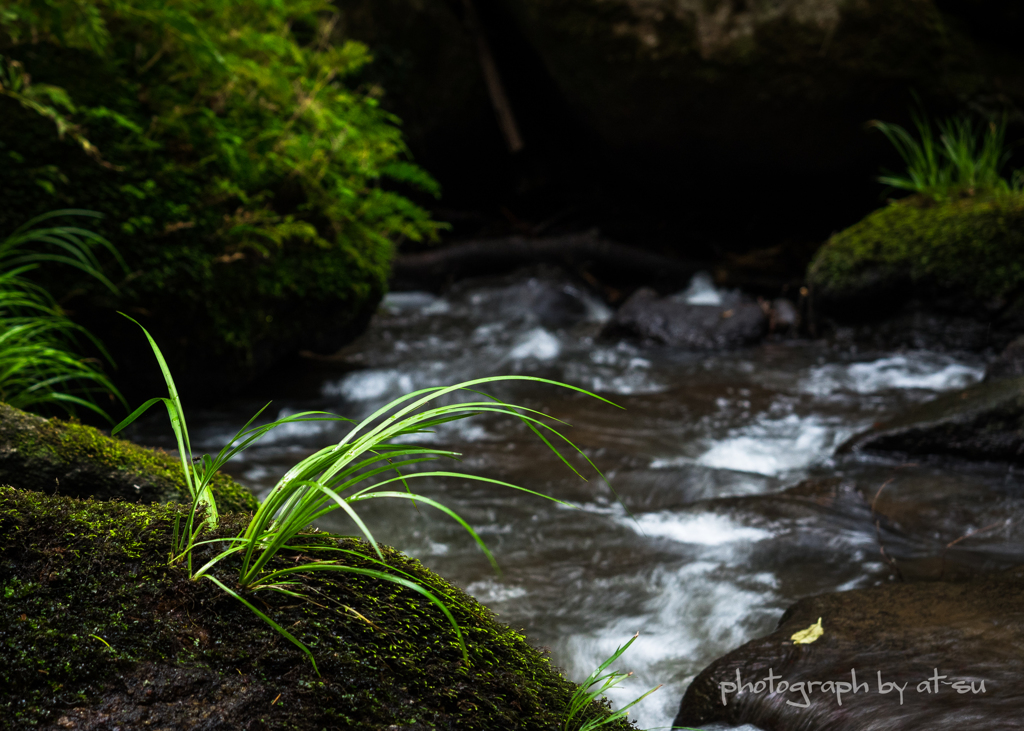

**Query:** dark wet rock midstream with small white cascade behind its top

left=605, top=288, right=768, bottom=350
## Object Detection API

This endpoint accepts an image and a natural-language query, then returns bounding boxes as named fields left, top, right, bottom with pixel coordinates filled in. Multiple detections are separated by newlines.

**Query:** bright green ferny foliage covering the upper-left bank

left=0, top=0, right=438, bottom=366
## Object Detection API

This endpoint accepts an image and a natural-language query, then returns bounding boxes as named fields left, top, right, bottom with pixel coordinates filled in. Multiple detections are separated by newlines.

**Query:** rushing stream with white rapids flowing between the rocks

left=133, top=271, right=1015, bottom=728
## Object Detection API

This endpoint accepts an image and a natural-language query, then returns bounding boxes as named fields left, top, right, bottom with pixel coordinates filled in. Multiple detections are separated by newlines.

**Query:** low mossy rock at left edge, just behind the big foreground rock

left=0, top=403, right=258, bottom=513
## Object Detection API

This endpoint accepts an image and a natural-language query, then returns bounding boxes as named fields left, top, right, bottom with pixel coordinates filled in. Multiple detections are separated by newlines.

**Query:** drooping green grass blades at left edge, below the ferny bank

left=0, top=210, right=123, bottom=421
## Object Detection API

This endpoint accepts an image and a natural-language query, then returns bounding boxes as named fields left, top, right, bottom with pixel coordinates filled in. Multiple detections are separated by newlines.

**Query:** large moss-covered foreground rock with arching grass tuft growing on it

left=0, top=487, right=629, bottom=731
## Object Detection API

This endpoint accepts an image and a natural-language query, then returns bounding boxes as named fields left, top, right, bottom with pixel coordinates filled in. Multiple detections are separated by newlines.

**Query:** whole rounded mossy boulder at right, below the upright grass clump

left=808, top=194, right=1024, bottom=348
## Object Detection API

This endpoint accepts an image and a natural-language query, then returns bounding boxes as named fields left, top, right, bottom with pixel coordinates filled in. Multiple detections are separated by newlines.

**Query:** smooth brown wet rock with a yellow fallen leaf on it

left=675, top=570, right=1024, bottom=731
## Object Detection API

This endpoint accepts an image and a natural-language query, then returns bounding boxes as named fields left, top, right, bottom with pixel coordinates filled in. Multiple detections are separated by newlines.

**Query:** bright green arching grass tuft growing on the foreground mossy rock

left=114, top=315, right=617, bottom=674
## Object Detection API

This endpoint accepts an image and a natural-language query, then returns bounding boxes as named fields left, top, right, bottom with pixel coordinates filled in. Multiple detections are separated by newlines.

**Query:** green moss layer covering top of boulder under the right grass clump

left=808, top=194, right=1024, bottom=301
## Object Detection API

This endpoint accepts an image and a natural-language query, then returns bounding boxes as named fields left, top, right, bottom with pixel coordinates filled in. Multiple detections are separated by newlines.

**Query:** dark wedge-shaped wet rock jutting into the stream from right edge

left=839, top=377, right=1024, bottom=464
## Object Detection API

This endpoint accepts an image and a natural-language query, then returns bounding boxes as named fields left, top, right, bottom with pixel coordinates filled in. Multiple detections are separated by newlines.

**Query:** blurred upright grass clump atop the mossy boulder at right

left=869, top=113, right=1024, bottom=200
